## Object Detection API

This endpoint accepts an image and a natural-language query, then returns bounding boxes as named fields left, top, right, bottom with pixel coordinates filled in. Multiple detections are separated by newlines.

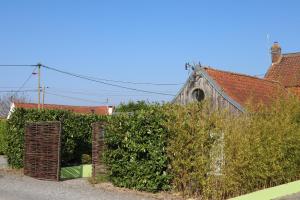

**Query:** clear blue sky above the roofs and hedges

left=0, top=0, right=300, bottom=105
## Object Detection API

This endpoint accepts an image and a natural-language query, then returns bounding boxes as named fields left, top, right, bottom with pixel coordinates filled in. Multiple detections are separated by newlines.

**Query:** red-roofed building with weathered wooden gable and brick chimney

left=173, top=43, right=300, bottom=113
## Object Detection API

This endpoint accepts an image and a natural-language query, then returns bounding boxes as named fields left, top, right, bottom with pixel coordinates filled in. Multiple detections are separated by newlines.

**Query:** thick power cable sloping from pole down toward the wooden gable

left=42, top=65, right=175, bottom=96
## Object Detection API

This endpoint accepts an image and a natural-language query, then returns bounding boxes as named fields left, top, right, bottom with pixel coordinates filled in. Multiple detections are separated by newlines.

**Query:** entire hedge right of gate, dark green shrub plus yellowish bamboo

left=104, top=97, right=300, bottom=199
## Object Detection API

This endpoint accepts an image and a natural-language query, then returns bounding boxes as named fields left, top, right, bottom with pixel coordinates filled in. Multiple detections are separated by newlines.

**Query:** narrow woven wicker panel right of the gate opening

left=92, top=122, right=106, bottom=177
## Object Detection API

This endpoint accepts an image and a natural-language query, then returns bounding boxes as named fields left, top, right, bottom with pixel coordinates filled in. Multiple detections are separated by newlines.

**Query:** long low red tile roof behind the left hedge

left=14, top=102, right=109, bottom=115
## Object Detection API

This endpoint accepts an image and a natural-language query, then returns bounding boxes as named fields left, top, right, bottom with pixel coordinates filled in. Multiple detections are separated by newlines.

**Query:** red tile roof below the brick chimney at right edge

left=265, top=53, right=300, bottom=87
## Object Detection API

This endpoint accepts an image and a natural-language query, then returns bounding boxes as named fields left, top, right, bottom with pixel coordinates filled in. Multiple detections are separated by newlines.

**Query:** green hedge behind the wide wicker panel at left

left=6, top=108, right=105, bottom=168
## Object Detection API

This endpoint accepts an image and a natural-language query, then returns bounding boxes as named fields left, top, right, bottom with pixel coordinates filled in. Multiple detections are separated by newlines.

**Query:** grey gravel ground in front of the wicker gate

left=0, top=173, right=153, bottom=200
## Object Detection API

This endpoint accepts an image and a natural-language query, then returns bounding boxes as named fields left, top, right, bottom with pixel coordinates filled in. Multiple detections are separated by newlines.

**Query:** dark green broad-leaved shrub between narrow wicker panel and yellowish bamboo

left=104, top=104, right=171, bottom=192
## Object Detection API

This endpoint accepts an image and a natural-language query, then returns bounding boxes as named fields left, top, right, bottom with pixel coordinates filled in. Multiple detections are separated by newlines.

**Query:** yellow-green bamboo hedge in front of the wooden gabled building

left=165, top=98, right=300, bottom=199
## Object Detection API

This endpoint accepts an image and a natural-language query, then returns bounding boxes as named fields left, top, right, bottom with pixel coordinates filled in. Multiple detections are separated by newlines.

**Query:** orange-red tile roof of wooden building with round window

left=204, top=67, right=286, bottom=106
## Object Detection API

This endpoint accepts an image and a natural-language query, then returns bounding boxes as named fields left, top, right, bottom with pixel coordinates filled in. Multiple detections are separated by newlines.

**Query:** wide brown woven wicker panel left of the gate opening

left=24, top=122, right=61, bottom=181
